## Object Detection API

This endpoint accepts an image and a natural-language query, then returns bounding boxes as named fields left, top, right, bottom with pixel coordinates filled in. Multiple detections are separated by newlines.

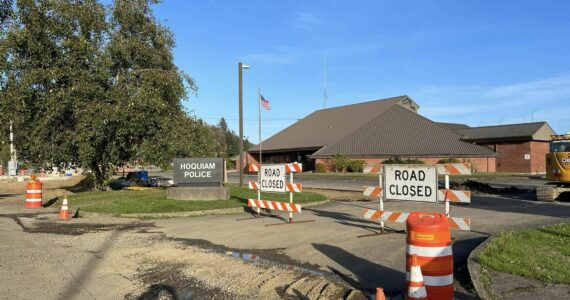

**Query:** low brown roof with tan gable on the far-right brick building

left=457, top=122, right=554, bottom=142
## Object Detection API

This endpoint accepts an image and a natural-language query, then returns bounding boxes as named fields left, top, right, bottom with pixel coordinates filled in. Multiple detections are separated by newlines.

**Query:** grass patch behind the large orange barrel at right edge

left=480, top=223, right=570, bottom=284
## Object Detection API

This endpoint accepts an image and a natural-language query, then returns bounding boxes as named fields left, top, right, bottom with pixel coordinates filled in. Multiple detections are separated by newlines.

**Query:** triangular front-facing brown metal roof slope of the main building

left=313, top=106, right=496, bottom=157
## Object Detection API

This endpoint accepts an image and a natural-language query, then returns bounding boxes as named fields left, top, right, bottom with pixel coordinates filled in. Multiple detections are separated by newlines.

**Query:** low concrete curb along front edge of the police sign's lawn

left=80, top=200, right=331, bottom=219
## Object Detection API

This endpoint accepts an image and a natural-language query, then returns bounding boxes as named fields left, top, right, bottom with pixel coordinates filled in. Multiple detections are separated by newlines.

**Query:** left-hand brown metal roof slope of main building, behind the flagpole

left=248, top=96, right=413, bottom=152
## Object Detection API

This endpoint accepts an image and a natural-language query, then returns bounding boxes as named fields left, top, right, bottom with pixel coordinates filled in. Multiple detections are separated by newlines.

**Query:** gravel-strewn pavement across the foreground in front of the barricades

left=0, top=178, right=570, bottom=299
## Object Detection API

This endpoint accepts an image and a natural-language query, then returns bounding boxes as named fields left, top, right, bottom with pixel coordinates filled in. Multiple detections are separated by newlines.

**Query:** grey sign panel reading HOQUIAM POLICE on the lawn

left=172, top=157, right=224, bottom=186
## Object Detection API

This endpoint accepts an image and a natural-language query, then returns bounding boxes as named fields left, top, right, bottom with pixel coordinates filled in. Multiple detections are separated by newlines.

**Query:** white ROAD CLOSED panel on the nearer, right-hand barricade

left=384, top=165, right=437, bottom=202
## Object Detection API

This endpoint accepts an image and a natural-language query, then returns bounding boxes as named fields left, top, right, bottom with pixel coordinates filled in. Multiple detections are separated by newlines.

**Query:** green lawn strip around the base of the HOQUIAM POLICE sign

left=68, top=187, right=326, bottom=214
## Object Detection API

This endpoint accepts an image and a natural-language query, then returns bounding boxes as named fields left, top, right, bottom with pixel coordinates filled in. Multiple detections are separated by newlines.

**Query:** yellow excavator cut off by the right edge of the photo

left=536, top=132, right=570, bottom=201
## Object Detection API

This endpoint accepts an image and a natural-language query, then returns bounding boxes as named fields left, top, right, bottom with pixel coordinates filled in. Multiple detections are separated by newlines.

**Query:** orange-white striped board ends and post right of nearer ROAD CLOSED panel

left=437, top=163, right=471, bottom=217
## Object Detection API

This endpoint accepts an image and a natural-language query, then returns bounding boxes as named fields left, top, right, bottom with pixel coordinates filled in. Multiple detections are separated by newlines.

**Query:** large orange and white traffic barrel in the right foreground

left=406, top=212, right=453, bottom=300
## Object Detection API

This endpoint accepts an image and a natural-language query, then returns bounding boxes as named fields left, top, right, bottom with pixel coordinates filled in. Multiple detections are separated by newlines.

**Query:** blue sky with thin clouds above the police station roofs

left=148, top=0, right=570, bottom=143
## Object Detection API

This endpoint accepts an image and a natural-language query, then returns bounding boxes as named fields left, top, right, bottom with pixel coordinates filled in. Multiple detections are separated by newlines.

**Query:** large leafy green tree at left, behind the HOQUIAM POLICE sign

left=0, top=0, right=247, bottom=187
